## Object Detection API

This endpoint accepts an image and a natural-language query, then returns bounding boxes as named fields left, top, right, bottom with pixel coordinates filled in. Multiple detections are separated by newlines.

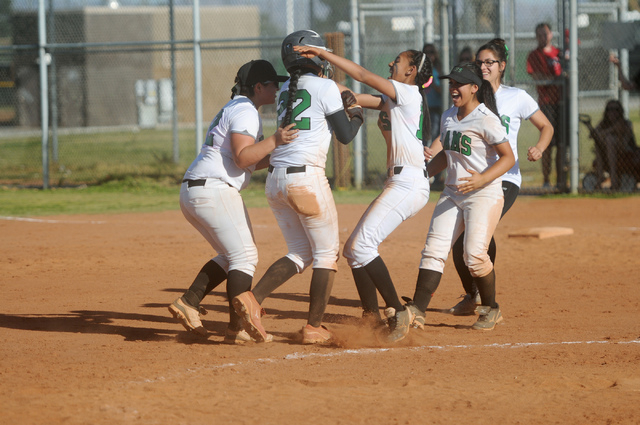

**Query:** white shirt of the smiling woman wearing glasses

left=496, top=85, right=540, bottom=187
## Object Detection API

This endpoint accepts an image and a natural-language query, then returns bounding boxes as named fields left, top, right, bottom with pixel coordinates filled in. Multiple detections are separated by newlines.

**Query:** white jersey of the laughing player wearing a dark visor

left=440, top=103, right=508, bottom=186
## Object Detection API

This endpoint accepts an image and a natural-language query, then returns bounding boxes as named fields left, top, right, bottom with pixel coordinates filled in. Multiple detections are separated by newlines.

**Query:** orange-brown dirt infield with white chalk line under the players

left=0, top=197, right=640, bottom=424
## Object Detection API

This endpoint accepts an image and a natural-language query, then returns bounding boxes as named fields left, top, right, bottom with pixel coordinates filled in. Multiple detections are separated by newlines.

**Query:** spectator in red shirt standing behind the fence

left=527, top=23, right=567, bottom=191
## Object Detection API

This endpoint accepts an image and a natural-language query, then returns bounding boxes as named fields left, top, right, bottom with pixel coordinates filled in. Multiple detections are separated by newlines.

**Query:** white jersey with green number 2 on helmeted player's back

left=270, top=73, right=344, bottom=168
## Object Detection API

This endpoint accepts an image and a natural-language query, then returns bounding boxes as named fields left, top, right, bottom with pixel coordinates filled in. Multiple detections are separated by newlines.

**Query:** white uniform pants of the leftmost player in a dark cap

left=180, top=179, right=258, bottom=276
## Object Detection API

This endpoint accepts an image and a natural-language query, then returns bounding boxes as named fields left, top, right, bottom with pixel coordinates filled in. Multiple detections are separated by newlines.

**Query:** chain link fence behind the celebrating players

left=0, top=0, right=640, bottom=193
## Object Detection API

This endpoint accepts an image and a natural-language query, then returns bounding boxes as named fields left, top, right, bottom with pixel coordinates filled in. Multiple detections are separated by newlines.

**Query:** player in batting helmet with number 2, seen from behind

left=233, top=30, right=363, bottom=344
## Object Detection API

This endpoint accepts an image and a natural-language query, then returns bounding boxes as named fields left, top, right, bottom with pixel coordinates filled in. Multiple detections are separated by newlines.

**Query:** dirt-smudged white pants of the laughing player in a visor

left=420, top=180, right=504, bottom=277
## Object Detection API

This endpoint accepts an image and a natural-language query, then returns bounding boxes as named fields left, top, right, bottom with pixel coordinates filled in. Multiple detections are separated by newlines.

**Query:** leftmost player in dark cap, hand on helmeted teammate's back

left=169, top=60, right=297, bottom=343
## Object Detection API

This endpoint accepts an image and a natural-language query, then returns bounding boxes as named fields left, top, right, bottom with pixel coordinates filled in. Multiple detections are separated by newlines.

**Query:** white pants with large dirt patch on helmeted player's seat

left=265, top=165, right=340, bottom=273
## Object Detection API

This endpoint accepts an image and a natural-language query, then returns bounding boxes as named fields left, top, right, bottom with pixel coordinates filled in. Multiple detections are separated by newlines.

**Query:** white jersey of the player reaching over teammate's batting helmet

left=381, top=80, right=425, bottom=169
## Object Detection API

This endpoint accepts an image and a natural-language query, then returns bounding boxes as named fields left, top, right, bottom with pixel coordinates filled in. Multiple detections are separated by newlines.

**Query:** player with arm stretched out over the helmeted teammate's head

left=296, top=46, right=433, bottom=342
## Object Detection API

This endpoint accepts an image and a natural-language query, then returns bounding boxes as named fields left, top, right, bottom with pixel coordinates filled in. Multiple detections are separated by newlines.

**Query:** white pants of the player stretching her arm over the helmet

left=343, top=167, right=429, bottom=268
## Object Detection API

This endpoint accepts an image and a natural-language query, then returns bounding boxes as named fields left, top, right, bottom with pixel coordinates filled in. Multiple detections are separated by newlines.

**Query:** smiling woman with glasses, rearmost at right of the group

left=442, top=38, right=553, bottom=315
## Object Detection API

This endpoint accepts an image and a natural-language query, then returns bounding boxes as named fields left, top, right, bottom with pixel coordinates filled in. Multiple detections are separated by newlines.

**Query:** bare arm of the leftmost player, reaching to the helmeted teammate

left=231, top=123, right=298, bottom=168
